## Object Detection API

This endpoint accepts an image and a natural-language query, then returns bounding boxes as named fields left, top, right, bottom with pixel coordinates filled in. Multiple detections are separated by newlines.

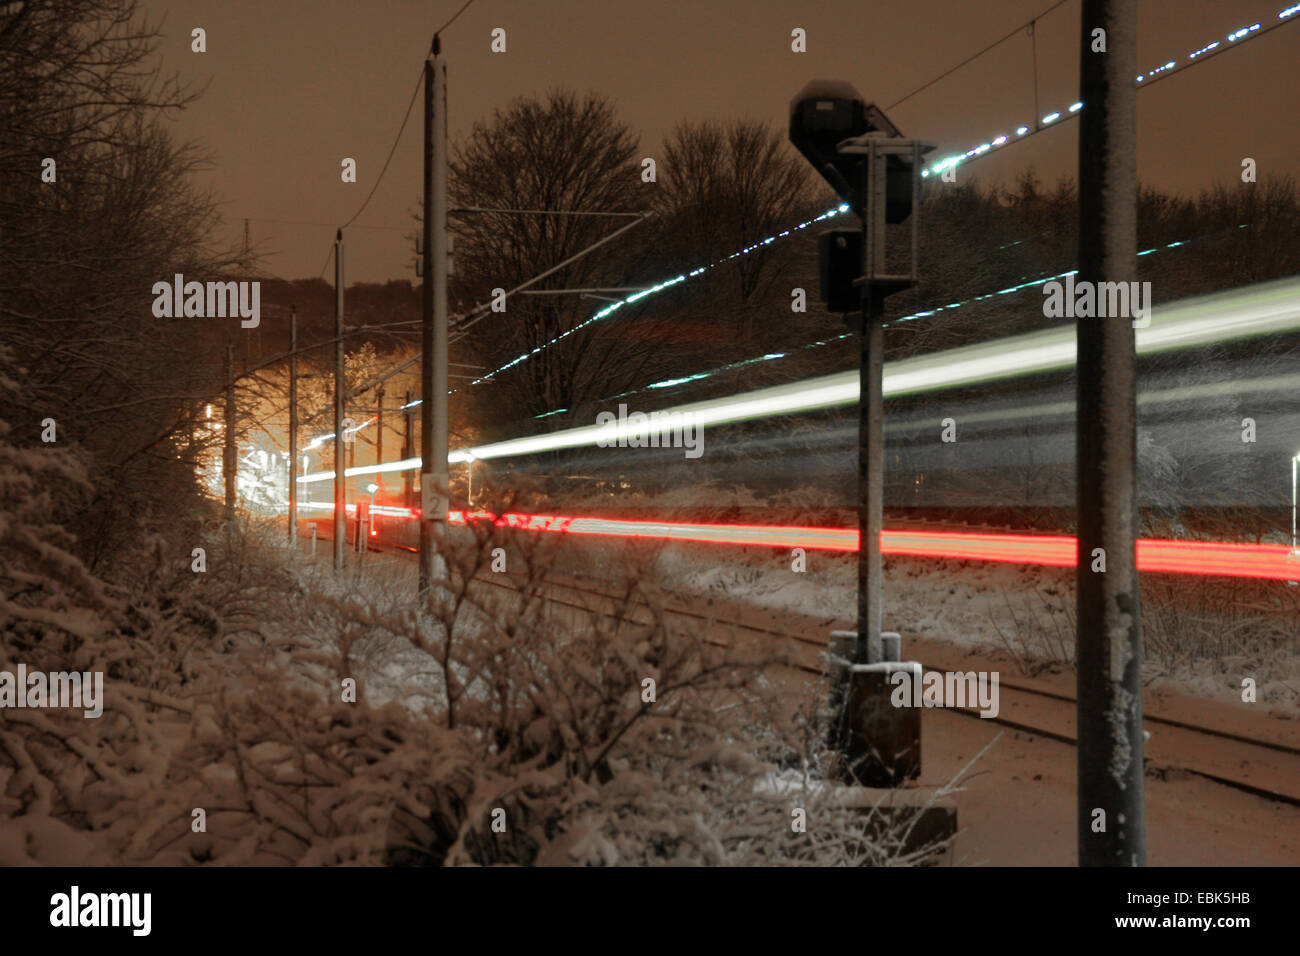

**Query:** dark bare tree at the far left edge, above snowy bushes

left=0, top=0, right=241, bottom=557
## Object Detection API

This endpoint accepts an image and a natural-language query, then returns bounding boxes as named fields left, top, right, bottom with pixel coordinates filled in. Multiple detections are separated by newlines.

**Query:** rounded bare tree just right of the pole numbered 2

left=450, top=91, right=655, bottom=421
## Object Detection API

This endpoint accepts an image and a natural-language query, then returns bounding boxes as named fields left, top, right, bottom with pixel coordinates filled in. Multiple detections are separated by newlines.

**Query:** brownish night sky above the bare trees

left=146, top=0, right=1300, bottom=282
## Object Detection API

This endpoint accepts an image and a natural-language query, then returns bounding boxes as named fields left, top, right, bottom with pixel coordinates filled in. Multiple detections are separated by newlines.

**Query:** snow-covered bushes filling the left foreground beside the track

left=0, top=411, right=956, bottom=865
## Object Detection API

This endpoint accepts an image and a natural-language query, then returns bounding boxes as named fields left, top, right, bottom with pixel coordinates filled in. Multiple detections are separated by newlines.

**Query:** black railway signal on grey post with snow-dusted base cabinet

left=790, top=81, right=933, bottom=786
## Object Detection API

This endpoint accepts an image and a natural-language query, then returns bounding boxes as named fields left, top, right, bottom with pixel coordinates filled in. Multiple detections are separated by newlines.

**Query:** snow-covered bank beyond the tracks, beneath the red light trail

left=559, top=540, right=1300, bottom=714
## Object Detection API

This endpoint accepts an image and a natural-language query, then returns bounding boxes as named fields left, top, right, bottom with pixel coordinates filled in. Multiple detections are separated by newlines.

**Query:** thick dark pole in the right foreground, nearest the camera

left=1075, top=0, right=1147, bottom=866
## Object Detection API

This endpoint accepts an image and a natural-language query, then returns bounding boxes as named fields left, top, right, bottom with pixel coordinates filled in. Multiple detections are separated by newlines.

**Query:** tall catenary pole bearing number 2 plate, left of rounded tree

left=420, top=35, right=449, bottom=600
